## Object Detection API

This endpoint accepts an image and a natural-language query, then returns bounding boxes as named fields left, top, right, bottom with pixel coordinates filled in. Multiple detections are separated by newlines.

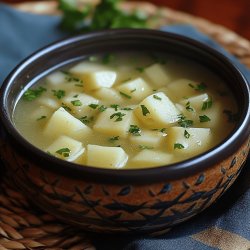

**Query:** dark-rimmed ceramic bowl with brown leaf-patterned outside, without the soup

left=0, top=30, right=250, bottom=233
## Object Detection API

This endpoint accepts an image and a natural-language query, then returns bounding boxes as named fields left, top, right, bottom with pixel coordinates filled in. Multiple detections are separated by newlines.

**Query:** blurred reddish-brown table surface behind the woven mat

left=2, top=0, right=250, bottom=40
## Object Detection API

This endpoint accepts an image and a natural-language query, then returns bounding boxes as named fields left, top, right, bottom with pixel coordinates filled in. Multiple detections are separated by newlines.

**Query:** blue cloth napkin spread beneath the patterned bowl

left=0, top=4, right=250, bottom=250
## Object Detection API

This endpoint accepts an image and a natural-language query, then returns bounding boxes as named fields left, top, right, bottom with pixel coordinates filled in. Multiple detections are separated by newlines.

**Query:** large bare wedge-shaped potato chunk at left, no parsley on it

left=44, top=107, right=91, bottom=139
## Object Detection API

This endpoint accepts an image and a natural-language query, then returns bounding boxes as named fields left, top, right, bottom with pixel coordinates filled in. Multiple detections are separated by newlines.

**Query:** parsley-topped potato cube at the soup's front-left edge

left=45, top=135, right=85, bottom=161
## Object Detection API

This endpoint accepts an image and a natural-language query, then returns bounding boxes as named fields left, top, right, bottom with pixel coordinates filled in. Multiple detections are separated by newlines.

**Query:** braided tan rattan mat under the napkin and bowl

left=0, top=0, right=250, bottom=250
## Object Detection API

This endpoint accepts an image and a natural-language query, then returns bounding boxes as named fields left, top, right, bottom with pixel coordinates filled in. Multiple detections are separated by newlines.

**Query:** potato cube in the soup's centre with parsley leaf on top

left=93, top=108, right=134, bottom=138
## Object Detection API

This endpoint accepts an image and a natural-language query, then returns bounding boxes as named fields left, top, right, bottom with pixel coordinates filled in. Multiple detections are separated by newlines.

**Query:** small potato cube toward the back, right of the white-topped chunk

left=117, top=78, right=152, bottom=101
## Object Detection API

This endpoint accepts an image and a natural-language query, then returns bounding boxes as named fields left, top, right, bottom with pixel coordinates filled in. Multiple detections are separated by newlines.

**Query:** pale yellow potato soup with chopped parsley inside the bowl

left=14, top=52, right=237, bottom=169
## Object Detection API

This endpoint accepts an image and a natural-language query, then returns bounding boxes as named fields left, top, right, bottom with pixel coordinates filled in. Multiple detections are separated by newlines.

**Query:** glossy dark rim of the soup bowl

left=0, top=29, right=250, bottom=183
